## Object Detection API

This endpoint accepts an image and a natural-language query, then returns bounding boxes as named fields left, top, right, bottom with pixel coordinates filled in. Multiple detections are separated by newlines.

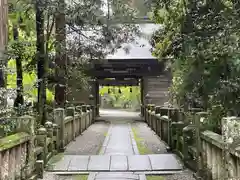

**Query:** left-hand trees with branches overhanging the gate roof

left=3, top=0, right=138, bottom=123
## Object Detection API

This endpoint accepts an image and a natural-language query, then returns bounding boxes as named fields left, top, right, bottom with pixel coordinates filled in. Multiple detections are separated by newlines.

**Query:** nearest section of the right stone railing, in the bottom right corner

left=201, top=131, right=240, bottom=180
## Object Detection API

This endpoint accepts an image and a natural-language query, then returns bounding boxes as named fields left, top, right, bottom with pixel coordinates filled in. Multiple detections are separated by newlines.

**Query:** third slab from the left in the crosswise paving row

left=88, top=155, right=110, bottom=171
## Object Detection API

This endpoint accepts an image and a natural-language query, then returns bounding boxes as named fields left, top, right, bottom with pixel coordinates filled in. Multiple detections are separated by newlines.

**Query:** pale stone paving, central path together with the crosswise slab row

left=46, top=110, right=182, bottom=180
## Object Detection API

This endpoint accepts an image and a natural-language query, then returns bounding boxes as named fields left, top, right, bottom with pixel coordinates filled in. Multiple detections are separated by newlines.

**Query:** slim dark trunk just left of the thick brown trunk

left=36, top=0, right=46, bottom=124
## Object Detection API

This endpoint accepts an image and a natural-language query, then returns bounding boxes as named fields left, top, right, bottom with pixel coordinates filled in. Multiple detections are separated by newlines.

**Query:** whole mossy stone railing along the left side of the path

left=0, top=105, right=95, bottom=180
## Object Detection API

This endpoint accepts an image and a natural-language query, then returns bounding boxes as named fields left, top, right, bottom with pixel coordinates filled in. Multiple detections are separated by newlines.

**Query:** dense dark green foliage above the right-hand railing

left=152, top=0, right=240, bottom=121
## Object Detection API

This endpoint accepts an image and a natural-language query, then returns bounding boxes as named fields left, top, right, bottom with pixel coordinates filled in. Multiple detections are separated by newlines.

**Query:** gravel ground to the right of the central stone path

left=132, top=122, right=195, bottom=180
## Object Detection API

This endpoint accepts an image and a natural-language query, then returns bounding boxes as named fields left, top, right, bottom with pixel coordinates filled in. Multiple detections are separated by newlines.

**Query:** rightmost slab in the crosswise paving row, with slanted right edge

left=148, top=154, right=182, bottom=171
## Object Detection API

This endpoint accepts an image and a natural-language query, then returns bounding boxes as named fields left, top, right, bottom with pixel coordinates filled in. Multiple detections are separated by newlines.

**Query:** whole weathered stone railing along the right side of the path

left=142, top=105, right=240, bottom=180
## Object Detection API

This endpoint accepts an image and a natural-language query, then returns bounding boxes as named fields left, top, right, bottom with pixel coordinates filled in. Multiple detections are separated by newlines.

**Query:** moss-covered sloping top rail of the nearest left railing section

left=0, top=132, right=30, bottom=151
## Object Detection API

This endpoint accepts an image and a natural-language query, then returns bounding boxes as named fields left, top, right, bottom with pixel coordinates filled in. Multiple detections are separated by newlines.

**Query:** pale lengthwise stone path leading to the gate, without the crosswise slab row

left=88, top=110, right=146, bottom=180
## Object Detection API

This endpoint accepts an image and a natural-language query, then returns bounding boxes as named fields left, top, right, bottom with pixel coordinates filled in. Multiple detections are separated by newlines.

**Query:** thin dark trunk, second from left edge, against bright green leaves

left=13, top=24, right=24, bottom=108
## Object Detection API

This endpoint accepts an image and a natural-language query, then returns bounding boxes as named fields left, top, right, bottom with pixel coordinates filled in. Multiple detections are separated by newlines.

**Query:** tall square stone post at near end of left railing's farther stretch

left=54, top=108, right=65, bottom=152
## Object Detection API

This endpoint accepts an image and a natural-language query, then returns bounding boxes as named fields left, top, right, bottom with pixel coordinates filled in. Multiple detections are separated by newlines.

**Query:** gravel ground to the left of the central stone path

left=39, top=121, right=109, bottom=180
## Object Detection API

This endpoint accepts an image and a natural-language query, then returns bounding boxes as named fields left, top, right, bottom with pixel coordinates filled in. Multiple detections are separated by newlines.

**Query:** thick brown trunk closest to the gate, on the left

left=55, top=0, right=67, bottom=107
